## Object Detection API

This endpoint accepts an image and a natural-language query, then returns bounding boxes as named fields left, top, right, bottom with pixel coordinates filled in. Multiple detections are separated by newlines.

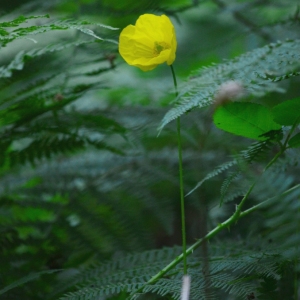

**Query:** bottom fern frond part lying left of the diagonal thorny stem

left=49, top=247, right=180, bottom=299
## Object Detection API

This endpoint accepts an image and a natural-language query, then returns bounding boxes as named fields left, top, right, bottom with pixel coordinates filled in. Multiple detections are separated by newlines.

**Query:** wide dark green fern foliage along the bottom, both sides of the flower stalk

left=53, top=246, right=296, bottom=300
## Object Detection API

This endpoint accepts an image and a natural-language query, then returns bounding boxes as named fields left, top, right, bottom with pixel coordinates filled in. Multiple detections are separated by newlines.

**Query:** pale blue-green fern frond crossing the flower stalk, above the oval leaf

left=160, top=40, right=300, bottom=130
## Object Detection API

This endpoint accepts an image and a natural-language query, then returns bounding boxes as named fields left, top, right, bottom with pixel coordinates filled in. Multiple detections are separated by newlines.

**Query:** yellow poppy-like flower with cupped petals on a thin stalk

left=119, top=14, right=177, bottom=71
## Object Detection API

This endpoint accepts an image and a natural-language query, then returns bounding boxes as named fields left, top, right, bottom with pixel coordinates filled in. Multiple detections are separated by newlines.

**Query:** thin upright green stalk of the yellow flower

left=171, top=65, right=187, bottom=275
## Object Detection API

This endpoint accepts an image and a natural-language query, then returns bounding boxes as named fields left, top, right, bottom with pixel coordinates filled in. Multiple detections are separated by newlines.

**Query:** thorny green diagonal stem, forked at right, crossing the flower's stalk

left=129, top=184, right=300, bottom=294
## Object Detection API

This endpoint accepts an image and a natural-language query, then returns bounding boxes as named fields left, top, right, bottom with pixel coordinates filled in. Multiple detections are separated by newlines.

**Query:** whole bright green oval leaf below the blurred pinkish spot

left=213, top=102, right=281, bottom=141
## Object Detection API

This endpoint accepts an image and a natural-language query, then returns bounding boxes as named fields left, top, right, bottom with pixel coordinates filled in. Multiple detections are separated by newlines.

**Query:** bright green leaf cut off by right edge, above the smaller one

left=272, top=97, right=300, bottom=126
